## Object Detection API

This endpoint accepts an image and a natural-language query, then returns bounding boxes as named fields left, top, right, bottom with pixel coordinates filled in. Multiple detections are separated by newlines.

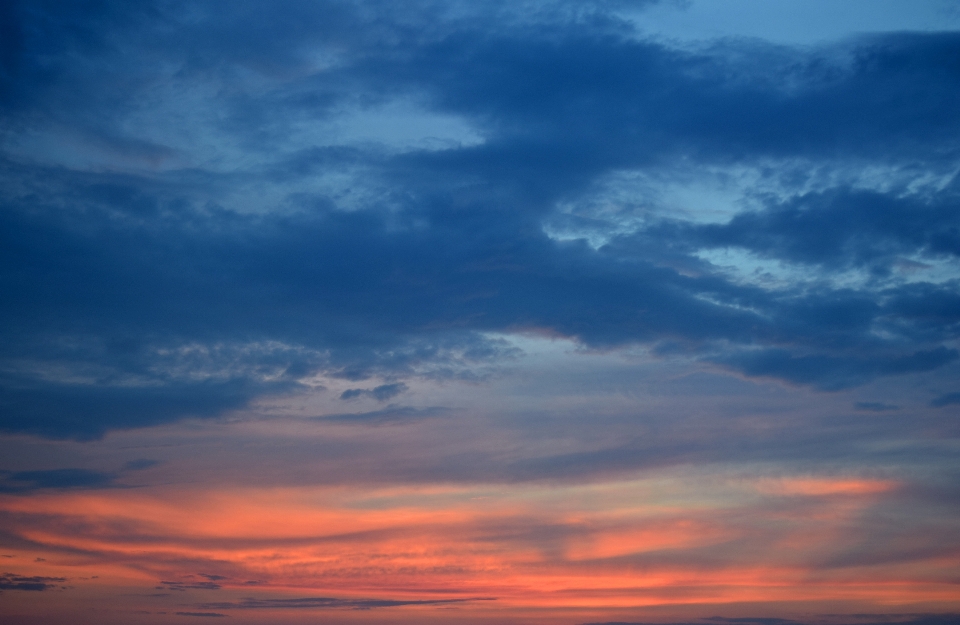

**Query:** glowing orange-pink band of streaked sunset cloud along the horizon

left=0, top=477, right=960, bottom=608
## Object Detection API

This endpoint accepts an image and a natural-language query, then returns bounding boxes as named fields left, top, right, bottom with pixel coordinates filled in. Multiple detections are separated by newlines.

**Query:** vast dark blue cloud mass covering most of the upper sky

left=0, top=2, right=960, bottom=439
